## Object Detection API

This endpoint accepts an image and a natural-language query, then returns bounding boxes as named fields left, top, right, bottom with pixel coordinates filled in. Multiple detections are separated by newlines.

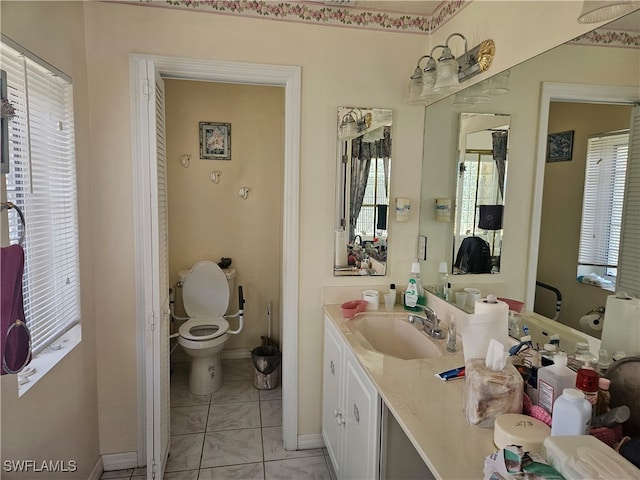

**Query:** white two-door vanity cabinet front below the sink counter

left=322, top=317, right=382, bottom=480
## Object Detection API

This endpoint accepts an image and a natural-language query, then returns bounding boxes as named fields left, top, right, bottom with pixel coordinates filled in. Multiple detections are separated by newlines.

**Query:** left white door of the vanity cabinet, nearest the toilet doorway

left=322, top=320, right=344, bottom=478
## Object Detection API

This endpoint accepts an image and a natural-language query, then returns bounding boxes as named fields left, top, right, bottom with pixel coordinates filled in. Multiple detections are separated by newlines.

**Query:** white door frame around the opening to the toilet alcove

left=129, top=54, right=301, bottom=465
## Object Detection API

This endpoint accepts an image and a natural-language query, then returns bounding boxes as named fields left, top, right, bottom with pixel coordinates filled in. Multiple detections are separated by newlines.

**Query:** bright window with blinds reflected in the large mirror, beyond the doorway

left=578, top=131, right=629, bottom=287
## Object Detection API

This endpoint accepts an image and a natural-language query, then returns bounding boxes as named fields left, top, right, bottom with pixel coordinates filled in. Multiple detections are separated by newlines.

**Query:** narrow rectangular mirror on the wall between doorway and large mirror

left=334, top=107, right=393, bottom=276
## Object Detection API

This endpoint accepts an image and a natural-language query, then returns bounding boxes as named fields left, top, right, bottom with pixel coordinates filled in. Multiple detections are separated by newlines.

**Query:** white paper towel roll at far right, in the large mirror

left=600, top=295, right=640, bottom=357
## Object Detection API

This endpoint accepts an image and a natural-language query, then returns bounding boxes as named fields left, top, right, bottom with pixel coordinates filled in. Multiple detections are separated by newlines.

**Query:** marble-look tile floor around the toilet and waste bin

left=101, top=359, right=331, bottom=480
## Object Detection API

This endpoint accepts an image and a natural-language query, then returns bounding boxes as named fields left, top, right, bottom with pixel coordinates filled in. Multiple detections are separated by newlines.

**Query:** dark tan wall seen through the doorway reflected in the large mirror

left=536, top=102, right=631, bottom=330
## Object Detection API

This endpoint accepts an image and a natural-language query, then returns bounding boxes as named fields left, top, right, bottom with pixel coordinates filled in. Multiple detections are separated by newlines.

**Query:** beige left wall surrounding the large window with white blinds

left=0, top=1, right=99, bottom=479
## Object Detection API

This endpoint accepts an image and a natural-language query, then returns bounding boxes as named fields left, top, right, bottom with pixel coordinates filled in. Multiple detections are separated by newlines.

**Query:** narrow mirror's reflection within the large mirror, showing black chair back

left=451, top=113, right=511, bottom=275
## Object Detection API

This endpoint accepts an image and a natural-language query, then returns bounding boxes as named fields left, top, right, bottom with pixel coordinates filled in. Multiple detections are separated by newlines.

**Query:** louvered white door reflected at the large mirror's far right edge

left=616, top=105, right=640, bottom=297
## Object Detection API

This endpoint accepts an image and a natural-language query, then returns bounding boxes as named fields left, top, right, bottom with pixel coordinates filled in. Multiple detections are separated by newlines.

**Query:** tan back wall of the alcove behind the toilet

left=165, top=80, right=284, bottom=350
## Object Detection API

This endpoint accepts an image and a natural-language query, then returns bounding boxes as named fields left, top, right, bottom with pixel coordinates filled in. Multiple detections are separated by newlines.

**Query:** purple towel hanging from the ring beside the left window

left=0, top=245, right=31, bottom=375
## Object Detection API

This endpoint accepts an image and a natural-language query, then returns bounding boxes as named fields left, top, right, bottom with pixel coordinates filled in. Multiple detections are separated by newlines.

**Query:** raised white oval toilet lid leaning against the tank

left=182, top=261, right=229, bottom=318
